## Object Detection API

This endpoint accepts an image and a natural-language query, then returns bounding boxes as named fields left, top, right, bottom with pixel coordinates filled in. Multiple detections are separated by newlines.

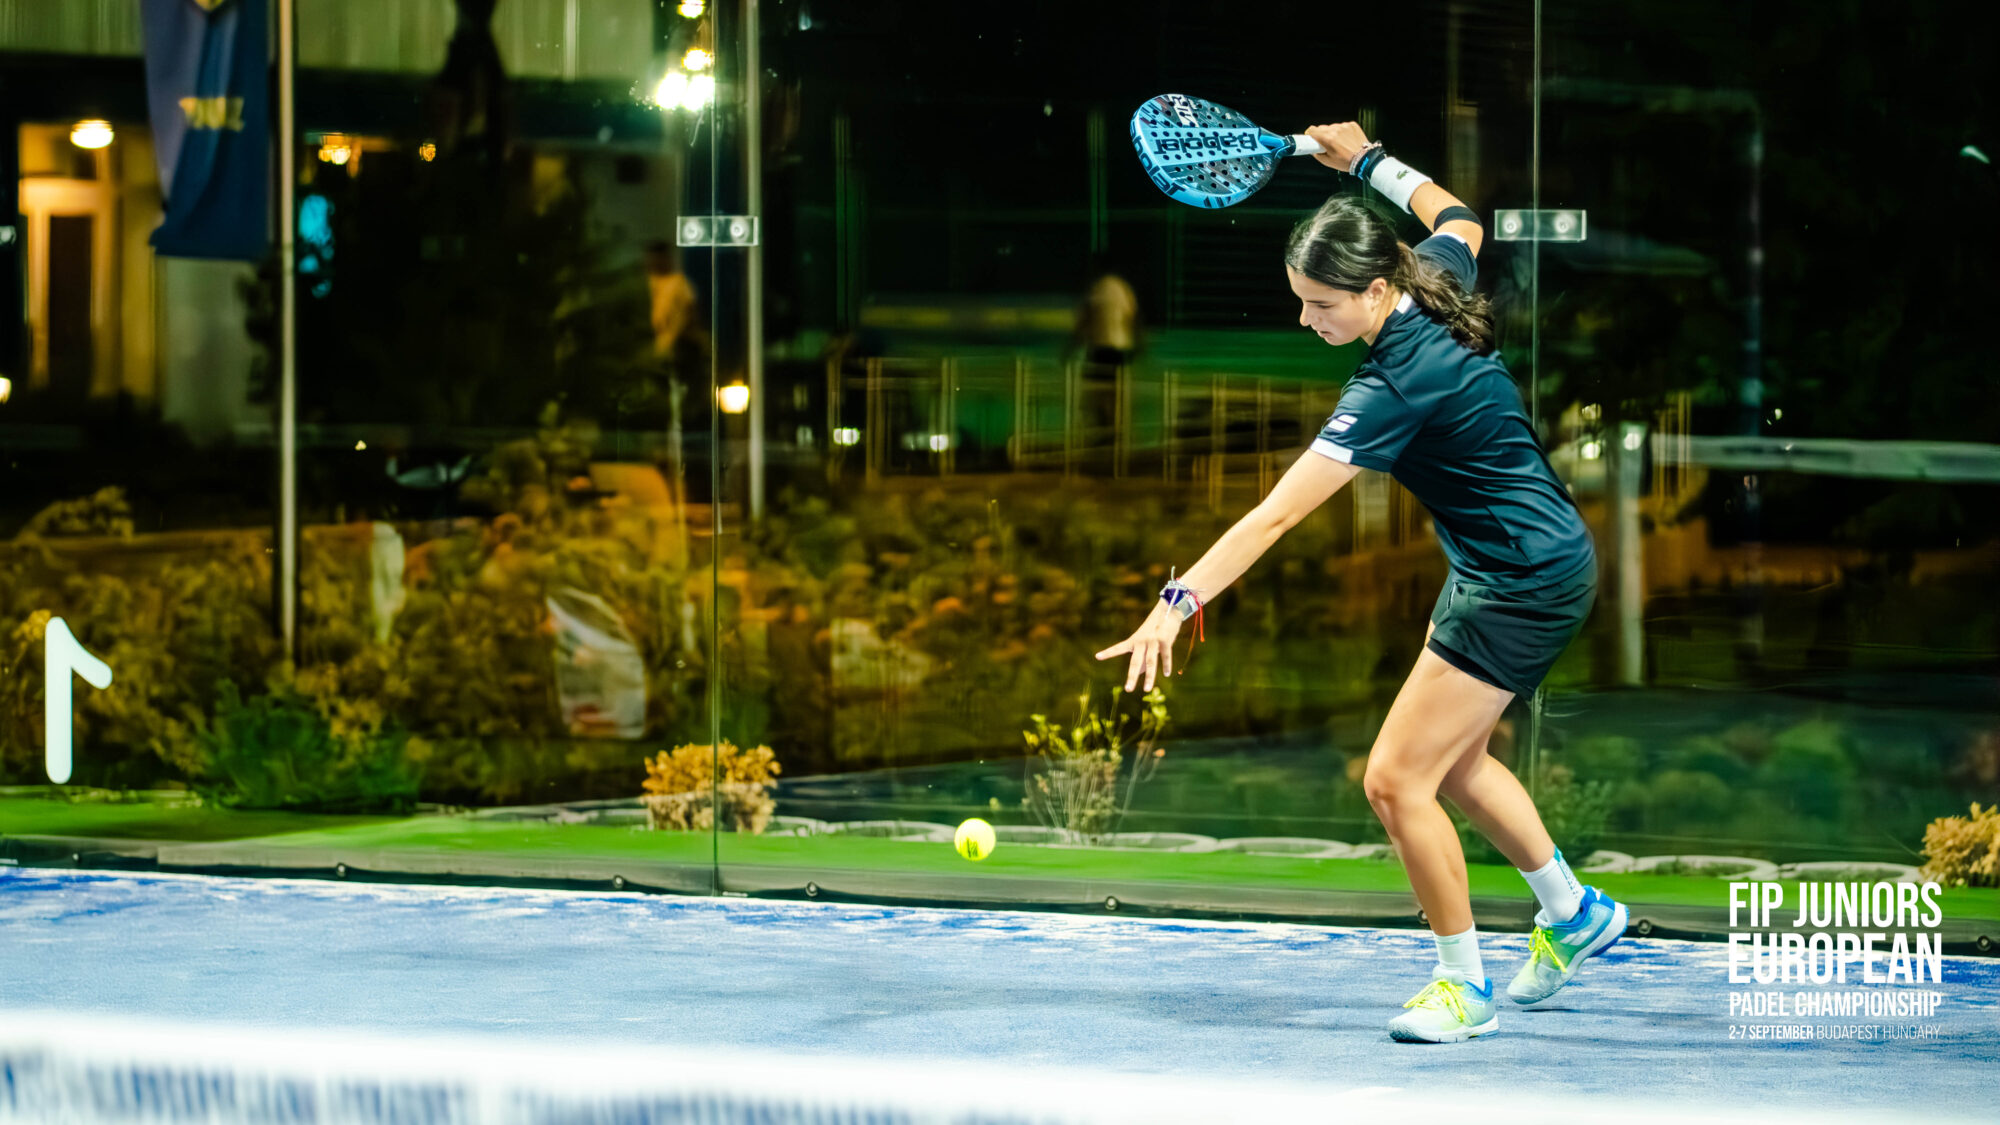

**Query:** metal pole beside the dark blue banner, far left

left=278, top=0, right=298, bottom=661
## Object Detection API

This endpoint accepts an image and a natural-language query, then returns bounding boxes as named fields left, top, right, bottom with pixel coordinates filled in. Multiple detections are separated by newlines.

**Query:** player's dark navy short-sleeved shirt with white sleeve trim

left=1312, top=234, right=1596, bottom=589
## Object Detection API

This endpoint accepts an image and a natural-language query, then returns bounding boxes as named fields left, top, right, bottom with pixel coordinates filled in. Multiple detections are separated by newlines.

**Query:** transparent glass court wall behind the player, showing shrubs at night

left=0, top=0, right=2000, bottom=917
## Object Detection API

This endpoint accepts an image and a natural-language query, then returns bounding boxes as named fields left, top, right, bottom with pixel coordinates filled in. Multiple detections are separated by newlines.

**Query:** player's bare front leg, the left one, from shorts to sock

left=1362, top=620, right=1532, bottom=935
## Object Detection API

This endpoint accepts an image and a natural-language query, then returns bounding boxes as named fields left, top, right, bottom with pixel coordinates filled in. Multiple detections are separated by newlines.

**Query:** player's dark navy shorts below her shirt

left=1426, top=558, right=1598, bottom=697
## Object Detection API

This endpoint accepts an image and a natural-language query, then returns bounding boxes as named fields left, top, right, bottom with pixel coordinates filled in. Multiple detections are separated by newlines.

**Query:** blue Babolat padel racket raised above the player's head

left=1132, top=94, right=1326, bottom=208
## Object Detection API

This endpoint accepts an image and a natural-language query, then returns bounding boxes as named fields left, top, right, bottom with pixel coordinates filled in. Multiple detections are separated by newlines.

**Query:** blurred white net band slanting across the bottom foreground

left=0, top=1011, right=1944, bottom=1125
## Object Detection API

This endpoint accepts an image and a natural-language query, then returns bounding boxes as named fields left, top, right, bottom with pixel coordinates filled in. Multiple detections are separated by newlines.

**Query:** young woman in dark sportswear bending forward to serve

left=1098, top=122, right=1626, bottom=1043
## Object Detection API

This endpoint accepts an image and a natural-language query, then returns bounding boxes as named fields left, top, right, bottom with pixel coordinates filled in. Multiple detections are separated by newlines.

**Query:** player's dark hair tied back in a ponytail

left=1284, top=196, right=1496, bottom=356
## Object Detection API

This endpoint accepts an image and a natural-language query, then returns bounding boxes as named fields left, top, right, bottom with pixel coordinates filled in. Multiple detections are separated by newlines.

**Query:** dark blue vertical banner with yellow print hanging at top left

left=140, top=0, right=270, bottom=262
